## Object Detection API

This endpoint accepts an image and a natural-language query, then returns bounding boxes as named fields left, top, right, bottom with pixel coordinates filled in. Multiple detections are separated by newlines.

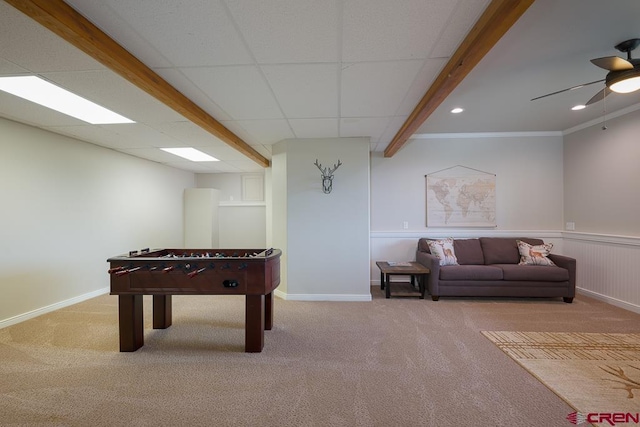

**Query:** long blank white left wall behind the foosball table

left=0, top=119, right=194, bottom=326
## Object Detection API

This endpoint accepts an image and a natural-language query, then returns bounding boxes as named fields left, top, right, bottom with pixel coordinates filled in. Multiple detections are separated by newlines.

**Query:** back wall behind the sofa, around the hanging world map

left=370, top=133, right=563, bottom=280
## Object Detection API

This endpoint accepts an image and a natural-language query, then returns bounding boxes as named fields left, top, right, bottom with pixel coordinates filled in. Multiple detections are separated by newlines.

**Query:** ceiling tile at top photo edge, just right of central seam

left=342, top=0, right=456, bottom=62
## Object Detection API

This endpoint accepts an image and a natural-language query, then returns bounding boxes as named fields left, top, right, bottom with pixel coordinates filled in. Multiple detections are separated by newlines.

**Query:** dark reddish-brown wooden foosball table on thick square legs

left=107, top=249, right=282, bottom=353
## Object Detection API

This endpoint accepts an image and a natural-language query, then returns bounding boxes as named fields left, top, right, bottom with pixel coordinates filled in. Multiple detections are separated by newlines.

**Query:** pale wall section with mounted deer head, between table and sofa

left=272, top=138, right=371, bottom=300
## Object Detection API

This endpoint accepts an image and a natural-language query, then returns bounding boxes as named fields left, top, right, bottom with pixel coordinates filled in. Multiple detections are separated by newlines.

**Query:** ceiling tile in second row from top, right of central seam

left=341, top=61, right=423, bottom=117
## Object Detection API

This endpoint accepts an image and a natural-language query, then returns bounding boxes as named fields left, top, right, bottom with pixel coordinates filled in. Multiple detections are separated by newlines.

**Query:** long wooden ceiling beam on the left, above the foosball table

left=5, top=0, right=269, bottom=171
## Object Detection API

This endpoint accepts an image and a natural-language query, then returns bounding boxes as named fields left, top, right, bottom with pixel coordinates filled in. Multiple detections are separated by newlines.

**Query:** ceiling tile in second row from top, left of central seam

left=261, top=63, right=338, bottom=119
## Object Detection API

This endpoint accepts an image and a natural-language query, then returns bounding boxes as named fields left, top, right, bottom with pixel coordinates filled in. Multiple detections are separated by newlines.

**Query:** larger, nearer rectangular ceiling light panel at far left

left=0, top=76, right=135, bottom=125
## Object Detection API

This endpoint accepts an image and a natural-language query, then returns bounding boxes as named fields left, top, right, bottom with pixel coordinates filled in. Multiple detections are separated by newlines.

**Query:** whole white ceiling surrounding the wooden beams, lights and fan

left=0, top=0, right=640, bottom=173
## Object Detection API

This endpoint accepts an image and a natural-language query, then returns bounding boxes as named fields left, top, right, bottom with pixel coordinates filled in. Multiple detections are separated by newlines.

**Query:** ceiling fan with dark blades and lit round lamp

left=532, top=39, right=640, bottom=105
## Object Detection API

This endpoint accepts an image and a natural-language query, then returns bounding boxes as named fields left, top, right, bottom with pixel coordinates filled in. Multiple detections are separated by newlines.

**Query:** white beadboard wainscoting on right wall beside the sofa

left=563, top=233, right=640, bottom=313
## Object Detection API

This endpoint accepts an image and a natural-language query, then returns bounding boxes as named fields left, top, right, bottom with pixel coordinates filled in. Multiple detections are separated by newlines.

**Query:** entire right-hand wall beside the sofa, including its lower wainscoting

left=564, top=111, right=640, bottom=313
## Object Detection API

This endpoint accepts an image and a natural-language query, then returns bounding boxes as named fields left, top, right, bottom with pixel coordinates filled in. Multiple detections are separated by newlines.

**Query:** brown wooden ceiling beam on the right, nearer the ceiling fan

left=384, top=0, right=534, bottom=157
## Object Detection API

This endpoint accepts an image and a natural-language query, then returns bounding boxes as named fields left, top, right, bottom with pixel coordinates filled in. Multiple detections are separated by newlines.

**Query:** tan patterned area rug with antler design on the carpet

left=482, top=331, right=640, bottom=414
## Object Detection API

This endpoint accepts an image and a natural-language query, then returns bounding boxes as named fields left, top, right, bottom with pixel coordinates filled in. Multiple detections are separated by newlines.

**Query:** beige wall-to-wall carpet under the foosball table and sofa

left=0, top=292, right=640, bottom=427
